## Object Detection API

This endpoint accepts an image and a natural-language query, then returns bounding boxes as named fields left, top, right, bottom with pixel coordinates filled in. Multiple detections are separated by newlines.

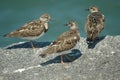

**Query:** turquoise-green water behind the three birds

left=0, top=0, right=120, bottom=47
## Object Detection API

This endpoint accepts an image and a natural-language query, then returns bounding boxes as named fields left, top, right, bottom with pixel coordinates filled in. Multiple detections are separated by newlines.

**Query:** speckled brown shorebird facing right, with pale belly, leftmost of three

left=4, top=14, right=51, bottom=48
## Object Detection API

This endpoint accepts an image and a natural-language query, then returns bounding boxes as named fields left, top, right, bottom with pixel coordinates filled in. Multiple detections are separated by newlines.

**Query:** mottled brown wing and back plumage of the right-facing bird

left=6, top=20, right=46, bottom=38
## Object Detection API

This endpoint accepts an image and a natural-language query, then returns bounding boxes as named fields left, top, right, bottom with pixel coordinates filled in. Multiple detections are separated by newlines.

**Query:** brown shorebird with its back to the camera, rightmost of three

left=85, top=6, right=105, bottom=42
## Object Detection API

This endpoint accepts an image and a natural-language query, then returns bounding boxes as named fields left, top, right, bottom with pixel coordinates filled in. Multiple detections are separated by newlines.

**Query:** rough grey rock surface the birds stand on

left=0, top=36, right=120, bottom=80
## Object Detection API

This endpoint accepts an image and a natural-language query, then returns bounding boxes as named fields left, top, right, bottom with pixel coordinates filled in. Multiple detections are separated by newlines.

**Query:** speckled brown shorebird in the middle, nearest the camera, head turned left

left=39, top=21, right=80, bottom=63
